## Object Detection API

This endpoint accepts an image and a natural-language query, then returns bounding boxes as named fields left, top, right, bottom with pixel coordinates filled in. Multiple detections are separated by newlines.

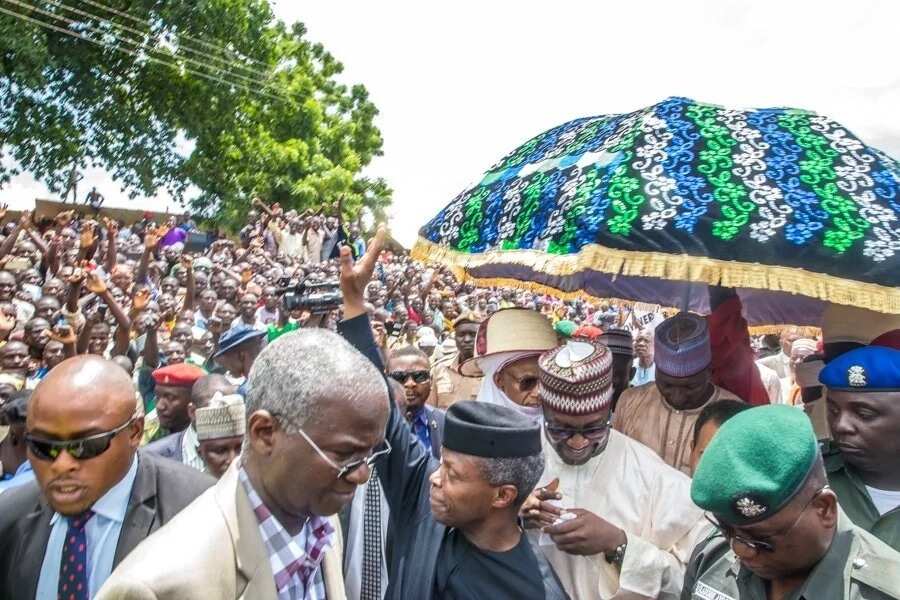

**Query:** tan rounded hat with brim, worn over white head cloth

left=459, top=308, right=557, bottom=377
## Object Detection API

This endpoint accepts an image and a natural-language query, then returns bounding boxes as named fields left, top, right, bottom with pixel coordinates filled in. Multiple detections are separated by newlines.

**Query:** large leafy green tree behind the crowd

left=0, top=0, right=391, bottom=225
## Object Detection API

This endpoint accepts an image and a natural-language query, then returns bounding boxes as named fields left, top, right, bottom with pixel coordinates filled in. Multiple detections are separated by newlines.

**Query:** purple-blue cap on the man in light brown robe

left=653, top=313, right=712, bottom=377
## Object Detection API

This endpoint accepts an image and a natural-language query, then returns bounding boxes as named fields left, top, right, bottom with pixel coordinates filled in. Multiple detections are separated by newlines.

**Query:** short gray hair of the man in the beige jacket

left=247, top=329, right=387, bottom=431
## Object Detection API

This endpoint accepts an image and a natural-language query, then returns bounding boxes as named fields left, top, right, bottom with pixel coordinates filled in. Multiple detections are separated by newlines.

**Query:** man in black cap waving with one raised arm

left=338, top=236, right=568, bottom=600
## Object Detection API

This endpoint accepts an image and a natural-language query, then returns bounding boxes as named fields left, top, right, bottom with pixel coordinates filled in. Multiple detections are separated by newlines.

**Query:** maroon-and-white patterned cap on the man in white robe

left=538, top=339, right=613, bottom=415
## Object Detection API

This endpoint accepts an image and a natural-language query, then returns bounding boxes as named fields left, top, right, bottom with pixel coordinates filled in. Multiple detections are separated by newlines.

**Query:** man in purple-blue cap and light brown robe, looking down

left=613, top=313, right=738, bottom=475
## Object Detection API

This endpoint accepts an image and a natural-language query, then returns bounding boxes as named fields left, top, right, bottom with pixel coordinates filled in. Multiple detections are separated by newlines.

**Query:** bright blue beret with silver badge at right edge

left=819, top=346, right=900, bottom=392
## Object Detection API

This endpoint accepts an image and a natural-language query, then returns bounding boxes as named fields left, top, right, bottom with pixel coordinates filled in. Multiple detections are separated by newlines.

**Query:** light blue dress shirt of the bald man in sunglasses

left=35, top=456, right=137, bottom=600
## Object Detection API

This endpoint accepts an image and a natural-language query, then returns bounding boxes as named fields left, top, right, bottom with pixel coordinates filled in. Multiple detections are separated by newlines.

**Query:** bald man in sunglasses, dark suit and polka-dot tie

left=0, top=355, right=215, bottom=600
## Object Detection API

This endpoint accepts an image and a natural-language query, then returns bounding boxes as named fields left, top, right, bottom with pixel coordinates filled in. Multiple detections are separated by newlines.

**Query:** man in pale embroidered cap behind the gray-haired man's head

left=194, top=392, right=247, bottom=479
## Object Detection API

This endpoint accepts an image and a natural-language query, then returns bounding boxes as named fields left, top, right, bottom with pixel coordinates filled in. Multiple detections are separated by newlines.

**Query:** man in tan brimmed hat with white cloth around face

left=460, top=308, right=557, bottom=421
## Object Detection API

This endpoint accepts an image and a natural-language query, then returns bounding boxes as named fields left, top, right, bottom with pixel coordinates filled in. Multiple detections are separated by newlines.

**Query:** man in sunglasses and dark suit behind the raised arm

left=388, top=346, right=444, bottom=458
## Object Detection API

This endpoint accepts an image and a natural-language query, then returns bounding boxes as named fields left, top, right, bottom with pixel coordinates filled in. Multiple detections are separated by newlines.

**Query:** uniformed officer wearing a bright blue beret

left=819, top=346, right=900, bottom=551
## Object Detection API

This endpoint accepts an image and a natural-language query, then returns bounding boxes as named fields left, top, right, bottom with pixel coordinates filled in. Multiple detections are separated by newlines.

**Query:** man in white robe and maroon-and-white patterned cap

left=522, top=340, right=708, bottom=600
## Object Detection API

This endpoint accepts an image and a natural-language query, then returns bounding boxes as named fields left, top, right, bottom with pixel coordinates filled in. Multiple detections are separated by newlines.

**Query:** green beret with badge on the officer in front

left=691, top=405, right=819, bottom=527
